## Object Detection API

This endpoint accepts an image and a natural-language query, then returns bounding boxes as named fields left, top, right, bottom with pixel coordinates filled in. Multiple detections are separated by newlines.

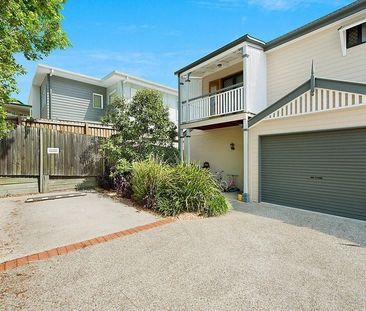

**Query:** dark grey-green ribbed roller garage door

left=260, top=129, right=366, bottom=220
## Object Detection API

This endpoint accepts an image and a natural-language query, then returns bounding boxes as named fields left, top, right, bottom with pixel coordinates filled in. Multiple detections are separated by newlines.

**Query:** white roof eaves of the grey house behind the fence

left=32, top=64, right=177, bottom=95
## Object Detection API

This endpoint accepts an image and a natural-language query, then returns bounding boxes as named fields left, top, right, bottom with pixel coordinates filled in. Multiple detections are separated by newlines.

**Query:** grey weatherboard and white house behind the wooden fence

left=29, top=65, right=178, bottom=123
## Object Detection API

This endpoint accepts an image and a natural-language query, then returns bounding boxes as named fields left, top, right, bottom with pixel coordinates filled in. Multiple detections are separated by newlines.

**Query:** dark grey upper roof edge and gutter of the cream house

left=175, top=0, right=366, bottom=74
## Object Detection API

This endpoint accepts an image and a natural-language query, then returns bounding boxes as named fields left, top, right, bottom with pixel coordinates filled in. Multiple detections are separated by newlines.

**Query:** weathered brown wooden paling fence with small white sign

left=0, top=126, right=103, bottom=195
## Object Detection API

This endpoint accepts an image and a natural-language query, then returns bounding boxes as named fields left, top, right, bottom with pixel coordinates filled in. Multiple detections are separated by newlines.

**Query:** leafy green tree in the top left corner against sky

left=0, top=0, right=70, bottom=135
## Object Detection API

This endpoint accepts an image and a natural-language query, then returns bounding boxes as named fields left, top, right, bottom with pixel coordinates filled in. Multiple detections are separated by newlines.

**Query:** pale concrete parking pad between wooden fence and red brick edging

left=0, top=192, right=156, bottom=262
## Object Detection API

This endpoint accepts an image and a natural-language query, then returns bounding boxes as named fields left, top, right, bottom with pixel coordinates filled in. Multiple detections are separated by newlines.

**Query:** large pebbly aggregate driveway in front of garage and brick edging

left=0, top=200, right=366, bottom=311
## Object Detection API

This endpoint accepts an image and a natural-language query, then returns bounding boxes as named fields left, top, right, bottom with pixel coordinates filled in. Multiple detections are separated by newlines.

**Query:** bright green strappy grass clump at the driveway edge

left=132, top=158, right=231, bottom=216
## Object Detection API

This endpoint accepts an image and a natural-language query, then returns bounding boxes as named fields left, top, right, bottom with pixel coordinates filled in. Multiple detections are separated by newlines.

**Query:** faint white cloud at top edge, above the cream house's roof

left=248, top=0, right=345, bottom=11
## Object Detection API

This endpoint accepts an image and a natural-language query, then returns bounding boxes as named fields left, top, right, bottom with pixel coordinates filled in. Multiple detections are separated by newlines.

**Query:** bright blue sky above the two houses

left=15, top=0, right=352, bottom=103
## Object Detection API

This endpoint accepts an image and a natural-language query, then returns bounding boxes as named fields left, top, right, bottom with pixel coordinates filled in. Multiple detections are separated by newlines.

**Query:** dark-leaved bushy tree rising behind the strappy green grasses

left=102, top=90, right=177, bottom=168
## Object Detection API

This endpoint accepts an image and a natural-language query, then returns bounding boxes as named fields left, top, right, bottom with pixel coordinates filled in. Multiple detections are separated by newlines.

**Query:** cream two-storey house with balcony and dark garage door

left=176, top=1, right=366, bottom=220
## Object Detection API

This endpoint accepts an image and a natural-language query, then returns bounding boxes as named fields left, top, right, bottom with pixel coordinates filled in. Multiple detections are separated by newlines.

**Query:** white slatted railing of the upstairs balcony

left=182, top=86, right=244, bottom=123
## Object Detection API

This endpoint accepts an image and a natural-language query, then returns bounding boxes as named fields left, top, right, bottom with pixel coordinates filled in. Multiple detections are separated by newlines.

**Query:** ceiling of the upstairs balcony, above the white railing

left=191, top=49, right=243, bottom=78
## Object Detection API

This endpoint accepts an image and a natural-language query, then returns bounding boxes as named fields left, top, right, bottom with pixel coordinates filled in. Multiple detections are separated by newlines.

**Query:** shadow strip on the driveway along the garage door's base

left=230, top=199, right=366, bottom=247
